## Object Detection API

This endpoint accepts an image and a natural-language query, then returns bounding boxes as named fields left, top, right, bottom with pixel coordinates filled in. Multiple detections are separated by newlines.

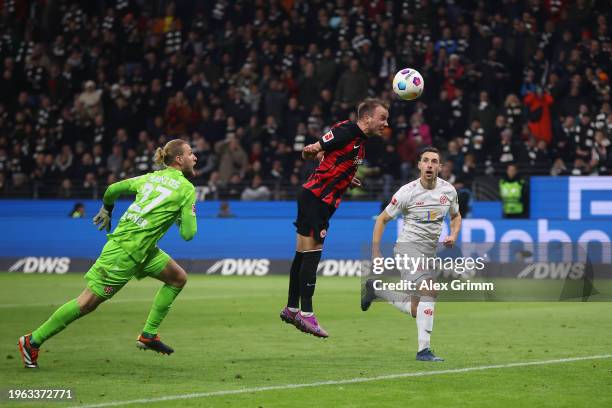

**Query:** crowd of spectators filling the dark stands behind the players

left=0, top=0, right=612, bottom=204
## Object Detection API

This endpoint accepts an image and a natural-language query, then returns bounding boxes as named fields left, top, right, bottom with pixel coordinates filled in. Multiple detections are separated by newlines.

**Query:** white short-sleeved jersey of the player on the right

left=385, top=177, right=459, bottom=252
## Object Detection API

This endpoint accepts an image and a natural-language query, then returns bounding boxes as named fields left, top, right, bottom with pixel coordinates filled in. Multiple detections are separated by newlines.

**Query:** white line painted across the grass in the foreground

left=75, top=354, right=612, bottom=408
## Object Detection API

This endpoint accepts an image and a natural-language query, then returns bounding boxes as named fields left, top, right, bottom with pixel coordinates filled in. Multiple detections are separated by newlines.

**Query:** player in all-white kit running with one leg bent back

left=361, top=147, right=461, bottom=361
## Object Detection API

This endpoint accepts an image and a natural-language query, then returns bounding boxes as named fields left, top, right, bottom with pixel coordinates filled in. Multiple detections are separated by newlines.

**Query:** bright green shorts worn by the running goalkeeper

left=85, top=240, right=170, bottom=299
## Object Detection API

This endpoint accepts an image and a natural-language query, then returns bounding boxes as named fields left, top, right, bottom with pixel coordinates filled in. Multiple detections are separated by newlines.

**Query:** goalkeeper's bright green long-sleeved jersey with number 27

left=103, top=167, right=197, bottom=262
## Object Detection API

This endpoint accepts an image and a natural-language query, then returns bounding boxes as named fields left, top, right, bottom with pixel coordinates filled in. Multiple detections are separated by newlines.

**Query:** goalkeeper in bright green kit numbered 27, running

left=19, top=139, right=197, bottom=368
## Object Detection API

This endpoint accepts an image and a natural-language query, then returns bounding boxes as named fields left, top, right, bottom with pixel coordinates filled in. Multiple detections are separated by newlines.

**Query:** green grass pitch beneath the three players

left=0, top=273, right=612, bottom=408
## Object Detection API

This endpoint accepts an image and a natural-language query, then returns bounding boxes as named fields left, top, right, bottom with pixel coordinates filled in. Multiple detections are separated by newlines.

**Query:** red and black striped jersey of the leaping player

left=304, top=120, right=366, bottom=207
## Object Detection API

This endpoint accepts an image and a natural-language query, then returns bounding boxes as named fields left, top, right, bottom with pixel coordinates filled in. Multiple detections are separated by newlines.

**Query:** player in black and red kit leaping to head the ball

left=280, top=99, right=389, bottom=337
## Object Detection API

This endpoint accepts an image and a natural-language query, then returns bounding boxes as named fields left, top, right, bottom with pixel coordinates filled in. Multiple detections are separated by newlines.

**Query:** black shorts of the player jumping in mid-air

left=293, top=187, right=336, bottom=243
